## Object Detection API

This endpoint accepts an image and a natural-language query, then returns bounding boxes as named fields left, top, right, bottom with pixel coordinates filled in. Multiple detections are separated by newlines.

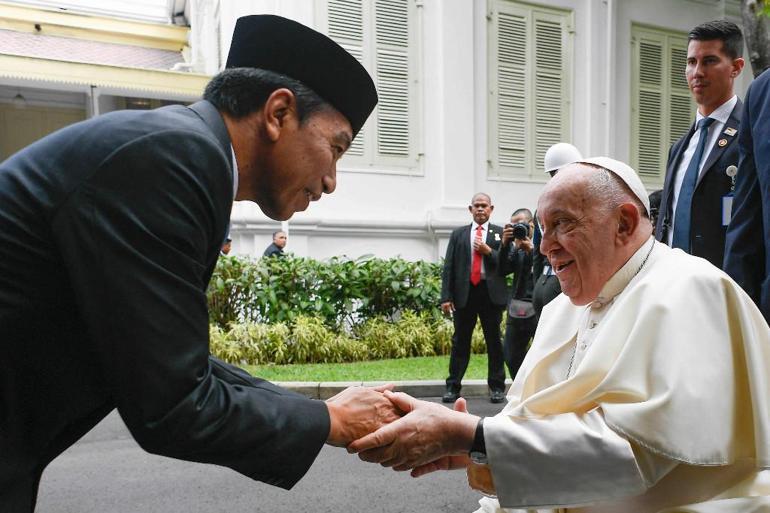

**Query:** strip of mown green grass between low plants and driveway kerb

left=243, top=354, right=487, bottom=381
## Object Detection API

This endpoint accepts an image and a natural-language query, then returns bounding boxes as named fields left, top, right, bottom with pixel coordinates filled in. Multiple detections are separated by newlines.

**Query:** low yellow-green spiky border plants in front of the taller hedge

left=211, top=311, right=486, bottom=365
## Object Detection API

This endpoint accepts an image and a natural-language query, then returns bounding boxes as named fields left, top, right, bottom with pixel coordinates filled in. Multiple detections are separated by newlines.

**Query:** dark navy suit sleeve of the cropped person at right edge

left=724, top=71, right=770, bottom=322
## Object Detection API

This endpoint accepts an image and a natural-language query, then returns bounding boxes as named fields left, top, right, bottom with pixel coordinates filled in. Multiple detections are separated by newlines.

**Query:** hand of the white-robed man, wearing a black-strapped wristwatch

left=348, top=392, right=479, bottom=470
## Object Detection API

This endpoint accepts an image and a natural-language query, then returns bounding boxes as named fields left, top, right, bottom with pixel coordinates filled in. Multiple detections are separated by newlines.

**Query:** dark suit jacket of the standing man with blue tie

left=655, top=100, right=743, bottom=267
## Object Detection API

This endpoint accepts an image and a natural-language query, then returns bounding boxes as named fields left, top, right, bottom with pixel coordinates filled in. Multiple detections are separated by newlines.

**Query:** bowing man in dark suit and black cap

left=0, top=16, right=397, bottom=512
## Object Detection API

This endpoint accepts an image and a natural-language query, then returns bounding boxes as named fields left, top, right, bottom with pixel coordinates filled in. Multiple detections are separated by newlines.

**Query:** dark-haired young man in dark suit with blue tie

left=655, top=20, right=744, bottom=267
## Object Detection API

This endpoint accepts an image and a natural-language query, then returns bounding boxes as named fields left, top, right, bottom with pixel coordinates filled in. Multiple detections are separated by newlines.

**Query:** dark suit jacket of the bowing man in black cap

left=0, top=102, right=329, bottom=511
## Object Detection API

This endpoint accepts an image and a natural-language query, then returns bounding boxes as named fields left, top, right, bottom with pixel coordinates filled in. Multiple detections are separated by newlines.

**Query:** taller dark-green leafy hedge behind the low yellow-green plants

left=208, top=256, right=441, bottom=332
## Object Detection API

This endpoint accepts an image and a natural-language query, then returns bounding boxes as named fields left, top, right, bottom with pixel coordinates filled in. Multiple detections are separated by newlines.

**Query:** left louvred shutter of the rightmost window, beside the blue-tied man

left=636, top=38, right=664, bottom=179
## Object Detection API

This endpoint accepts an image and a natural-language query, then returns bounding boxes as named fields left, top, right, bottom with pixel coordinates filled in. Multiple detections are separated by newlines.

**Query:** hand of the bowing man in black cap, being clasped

left=326, top=385, right=402, bottom=447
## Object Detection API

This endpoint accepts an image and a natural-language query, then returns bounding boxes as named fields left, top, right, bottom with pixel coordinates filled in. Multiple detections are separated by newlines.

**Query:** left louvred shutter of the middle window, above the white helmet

left=496, top=12, right=528, bottom=172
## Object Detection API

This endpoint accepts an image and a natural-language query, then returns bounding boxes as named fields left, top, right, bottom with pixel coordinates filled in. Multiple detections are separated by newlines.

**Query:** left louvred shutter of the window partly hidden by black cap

left=327, top=0, right=366, bottom=156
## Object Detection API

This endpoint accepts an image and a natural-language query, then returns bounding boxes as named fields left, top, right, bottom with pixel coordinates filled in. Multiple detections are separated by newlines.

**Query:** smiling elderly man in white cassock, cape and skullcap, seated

left=349, top=157, right=770, bottom=513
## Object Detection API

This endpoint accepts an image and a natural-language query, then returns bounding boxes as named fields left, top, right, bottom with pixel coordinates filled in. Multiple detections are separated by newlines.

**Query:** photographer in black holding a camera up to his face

left=498, top=208, right=537, bottom=379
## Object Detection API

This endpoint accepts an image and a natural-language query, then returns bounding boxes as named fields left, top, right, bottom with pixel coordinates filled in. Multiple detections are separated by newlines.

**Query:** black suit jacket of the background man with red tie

left=441, top=223, right=508, bottom=308
